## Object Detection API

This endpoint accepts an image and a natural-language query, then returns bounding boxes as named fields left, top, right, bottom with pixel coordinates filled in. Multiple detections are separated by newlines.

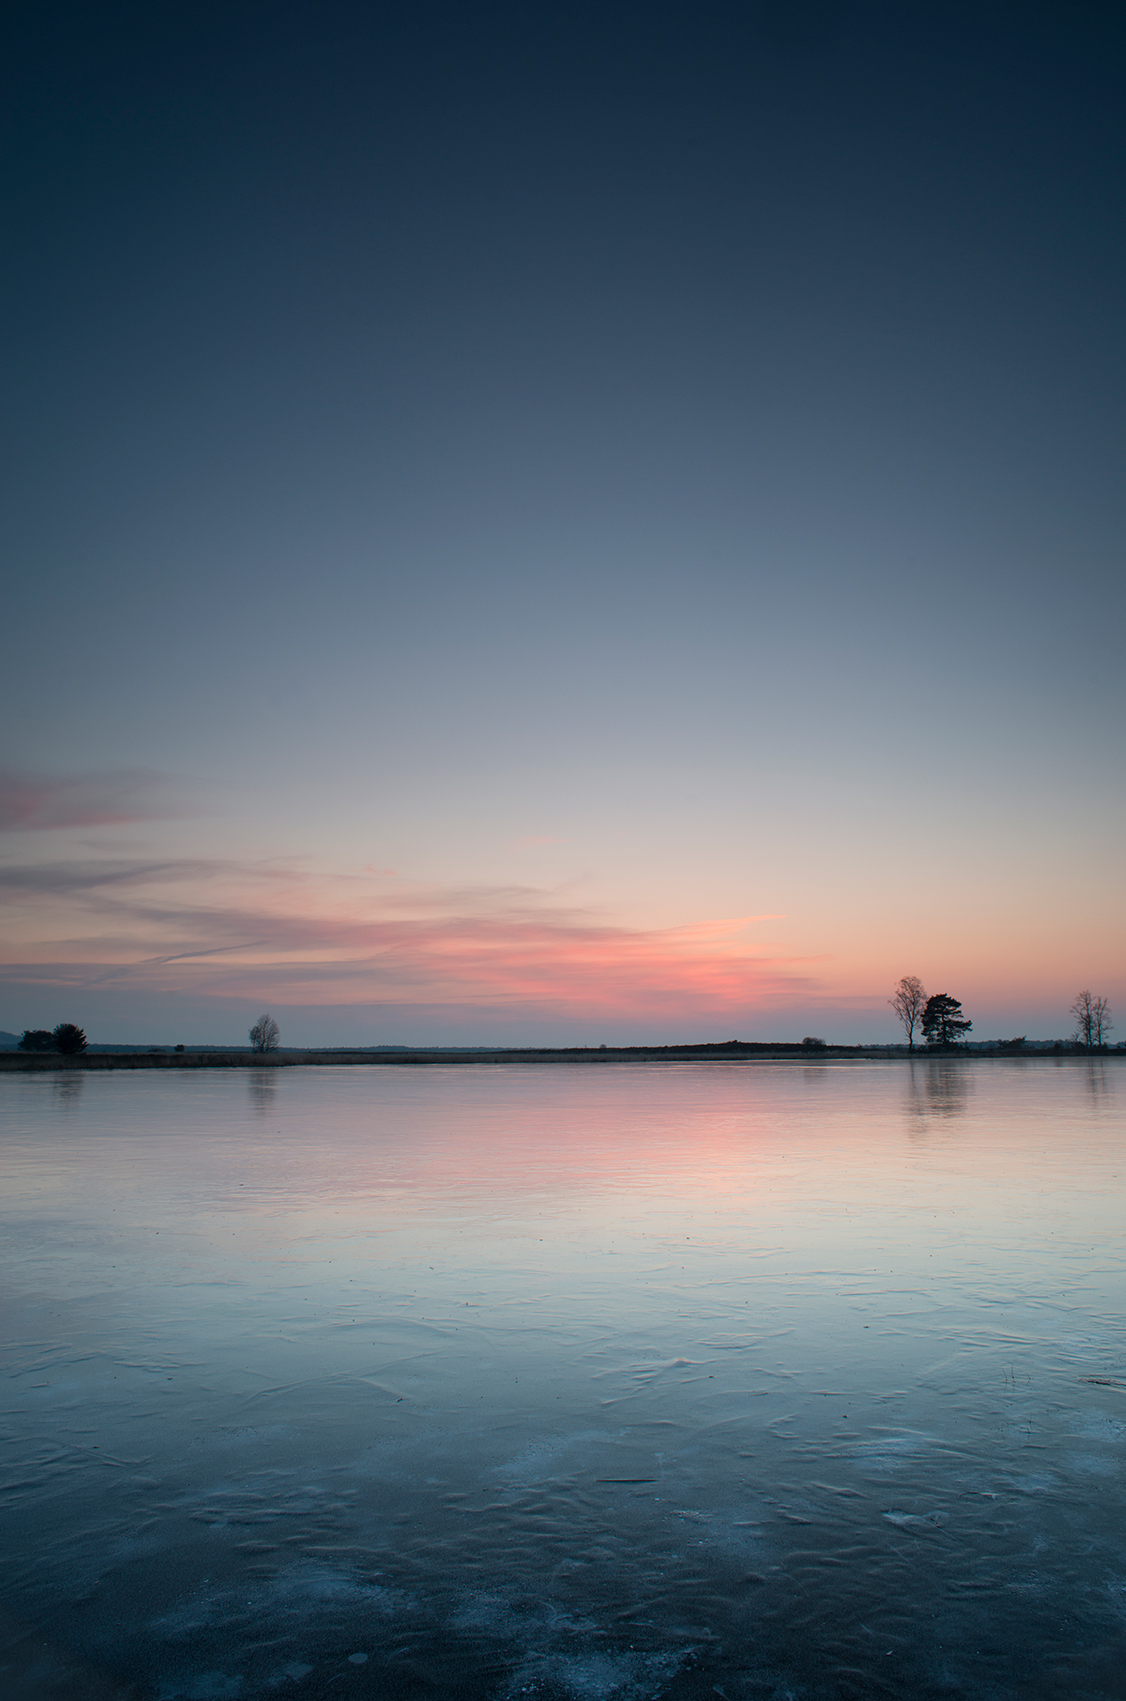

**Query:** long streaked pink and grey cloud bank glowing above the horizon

left=0, top=861, right=816, bottom=1015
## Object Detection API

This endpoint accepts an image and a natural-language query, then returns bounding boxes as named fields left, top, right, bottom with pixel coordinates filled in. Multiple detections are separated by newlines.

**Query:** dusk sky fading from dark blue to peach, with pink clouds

left=0, top=0, right=1126, bottom=1044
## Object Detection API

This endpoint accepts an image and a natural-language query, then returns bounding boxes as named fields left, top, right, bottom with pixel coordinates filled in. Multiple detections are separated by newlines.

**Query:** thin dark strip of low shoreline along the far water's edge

left=0, top=1039, right=1126, bottom=1072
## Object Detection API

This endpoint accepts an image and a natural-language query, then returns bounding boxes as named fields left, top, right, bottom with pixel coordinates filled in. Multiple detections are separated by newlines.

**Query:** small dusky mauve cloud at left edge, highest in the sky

left=0, top=769, right=187, bottom=832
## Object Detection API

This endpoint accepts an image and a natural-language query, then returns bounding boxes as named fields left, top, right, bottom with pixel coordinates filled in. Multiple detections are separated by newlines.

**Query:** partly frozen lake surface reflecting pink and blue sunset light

left=0, top=1058, right=1126, bottom=1701
